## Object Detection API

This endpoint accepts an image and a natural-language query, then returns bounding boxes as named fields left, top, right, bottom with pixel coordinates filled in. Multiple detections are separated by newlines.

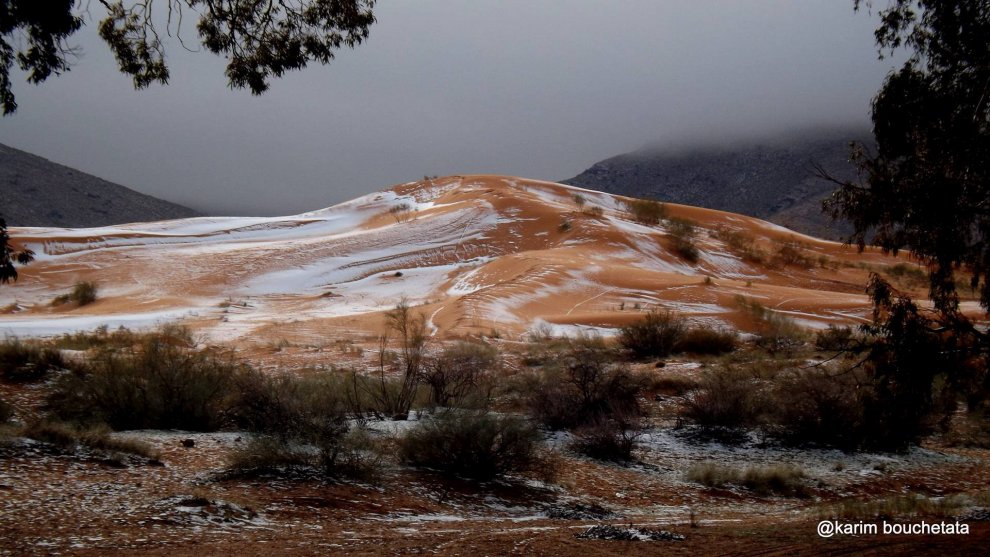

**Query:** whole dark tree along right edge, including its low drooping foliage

left=826, top=0, right=990, bottom=448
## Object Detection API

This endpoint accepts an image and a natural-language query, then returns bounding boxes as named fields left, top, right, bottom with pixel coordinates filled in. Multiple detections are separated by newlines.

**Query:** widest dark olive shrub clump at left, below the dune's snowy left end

left=48, top=327, right=245, bottom=431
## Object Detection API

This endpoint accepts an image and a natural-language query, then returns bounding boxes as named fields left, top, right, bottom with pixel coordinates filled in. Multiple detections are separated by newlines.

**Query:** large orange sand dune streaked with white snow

left=0, top=176, right=916, bottom=341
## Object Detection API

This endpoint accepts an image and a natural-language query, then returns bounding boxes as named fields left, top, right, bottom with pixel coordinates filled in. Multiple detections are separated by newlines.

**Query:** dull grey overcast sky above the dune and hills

left=0, top=0, right=892, bottom=215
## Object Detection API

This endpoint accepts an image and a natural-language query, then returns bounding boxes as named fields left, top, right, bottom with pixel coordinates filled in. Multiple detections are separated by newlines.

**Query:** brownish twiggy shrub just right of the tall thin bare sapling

left=423, top=342, right=499, bottom=407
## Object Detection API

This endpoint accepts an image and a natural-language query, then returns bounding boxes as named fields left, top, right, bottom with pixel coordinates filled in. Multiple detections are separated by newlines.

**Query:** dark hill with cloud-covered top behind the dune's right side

left=563, top=130, right=871, bottom=239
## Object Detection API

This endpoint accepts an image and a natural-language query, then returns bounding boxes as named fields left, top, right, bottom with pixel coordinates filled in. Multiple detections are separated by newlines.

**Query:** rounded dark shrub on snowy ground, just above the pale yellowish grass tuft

left=682, top=370, right=761, bottom=430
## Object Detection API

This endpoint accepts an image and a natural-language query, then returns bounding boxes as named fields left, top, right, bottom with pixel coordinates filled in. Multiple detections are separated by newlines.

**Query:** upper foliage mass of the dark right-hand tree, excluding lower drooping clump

left=828, top=0, right=990, bottom=313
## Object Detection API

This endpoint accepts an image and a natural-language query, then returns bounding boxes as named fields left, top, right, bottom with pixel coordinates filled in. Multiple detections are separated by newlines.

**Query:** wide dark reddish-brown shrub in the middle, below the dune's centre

left=528, top=345, right=643, bottom=429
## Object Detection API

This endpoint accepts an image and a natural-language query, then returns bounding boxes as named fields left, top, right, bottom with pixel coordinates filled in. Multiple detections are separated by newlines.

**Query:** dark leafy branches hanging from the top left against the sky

left=0, top=0, right=375, bottom=115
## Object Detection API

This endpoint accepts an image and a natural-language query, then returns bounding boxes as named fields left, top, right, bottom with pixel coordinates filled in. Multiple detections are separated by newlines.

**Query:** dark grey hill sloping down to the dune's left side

left=0, top=144, right=198, bottom=228
